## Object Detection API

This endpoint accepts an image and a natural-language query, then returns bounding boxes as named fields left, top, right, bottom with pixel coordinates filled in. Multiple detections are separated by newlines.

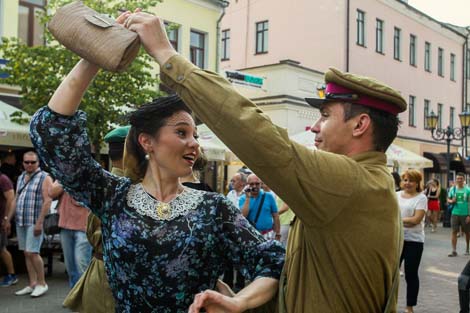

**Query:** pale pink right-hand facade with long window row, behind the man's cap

left=349, top=0, right=465, bottom=140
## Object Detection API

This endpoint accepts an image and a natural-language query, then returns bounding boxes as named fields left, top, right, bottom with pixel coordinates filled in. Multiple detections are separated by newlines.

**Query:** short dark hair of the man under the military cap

left=343, top=102, right=400, bottom=152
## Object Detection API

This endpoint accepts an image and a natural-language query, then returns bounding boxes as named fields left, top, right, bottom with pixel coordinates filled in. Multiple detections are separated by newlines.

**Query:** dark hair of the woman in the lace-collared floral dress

left=125, top=95, right=192, bottom=179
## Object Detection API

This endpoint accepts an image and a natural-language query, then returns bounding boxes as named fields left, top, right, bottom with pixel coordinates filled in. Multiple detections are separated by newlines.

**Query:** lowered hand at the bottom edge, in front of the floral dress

left=188, top=290, right=247, bottom=313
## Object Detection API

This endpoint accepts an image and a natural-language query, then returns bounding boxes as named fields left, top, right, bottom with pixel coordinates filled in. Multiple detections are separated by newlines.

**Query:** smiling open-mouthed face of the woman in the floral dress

left=150, top=111, right=199, bottom=177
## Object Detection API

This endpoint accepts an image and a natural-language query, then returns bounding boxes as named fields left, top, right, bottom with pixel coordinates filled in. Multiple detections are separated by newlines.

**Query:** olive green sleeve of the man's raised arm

left=161, top=55, right=356, bottom=225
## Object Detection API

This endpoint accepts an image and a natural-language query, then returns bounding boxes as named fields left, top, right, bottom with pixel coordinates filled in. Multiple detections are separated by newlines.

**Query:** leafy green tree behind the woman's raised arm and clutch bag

left=0, top=0, right=160, bottom=159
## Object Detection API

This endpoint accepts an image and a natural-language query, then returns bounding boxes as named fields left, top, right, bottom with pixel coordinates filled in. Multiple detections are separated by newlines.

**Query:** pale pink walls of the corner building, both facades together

left=221, top=0, right=465, bottom=141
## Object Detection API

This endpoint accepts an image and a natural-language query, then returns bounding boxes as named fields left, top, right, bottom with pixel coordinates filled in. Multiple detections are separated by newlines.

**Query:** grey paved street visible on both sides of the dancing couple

left=0, top=223, right=470, bottom=313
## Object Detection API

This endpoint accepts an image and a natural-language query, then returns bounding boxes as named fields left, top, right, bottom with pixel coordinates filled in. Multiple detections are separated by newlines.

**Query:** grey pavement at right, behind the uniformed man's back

left=398, top=227, right=470, bottom=313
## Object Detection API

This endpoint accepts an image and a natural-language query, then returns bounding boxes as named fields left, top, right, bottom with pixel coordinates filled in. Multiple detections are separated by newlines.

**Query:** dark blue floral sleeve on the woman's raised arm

left=30, top=106, right=123, bottom=216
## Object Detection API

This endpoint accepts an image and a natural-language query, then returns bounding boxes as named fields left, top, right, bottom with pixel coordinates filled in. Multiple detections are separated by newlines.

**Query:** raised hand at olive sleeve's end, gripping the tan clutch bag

left=124, top=9, right=177, bottom=65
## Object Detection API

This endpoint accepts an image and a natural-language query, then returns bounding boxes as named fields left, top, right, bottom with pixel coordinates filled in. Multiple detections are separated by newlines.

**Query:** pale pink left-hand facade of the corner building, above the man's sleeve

left=221, top=0, right=346, bottom=72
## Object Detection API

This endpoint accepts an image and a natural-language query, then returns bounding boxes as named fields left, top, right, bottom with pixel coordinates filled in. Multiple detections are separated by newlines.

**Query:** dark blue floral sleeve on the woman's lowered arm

left=217, top=197, right=285, bottom=280
